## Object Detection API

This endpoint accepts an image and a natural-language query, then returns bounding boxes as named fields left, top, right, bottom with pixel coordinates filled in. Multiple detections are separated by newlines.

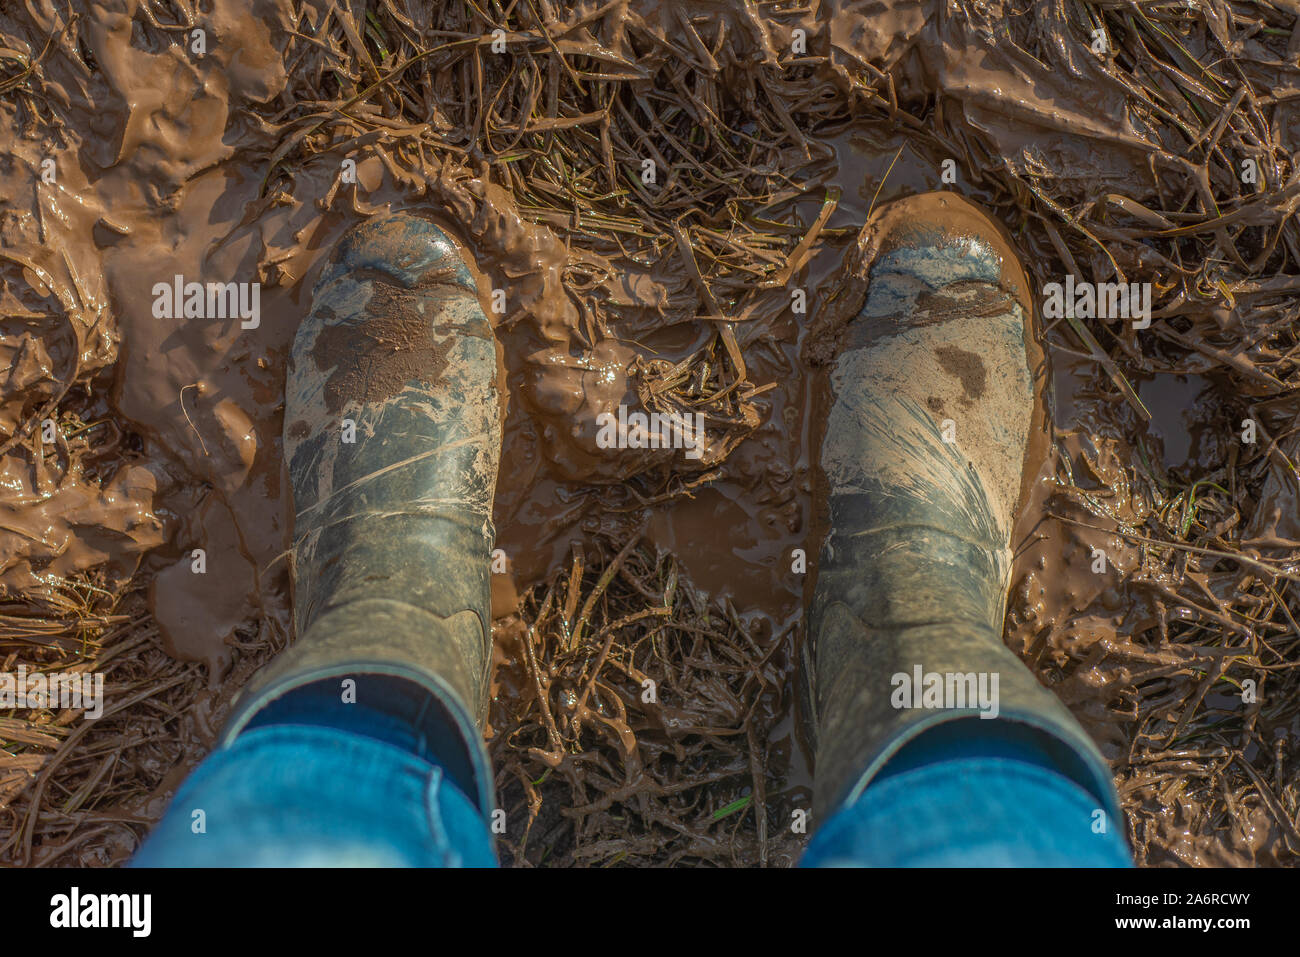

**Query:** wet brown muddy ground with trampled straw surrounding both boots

left=0, top=0, right=1300, bottom=866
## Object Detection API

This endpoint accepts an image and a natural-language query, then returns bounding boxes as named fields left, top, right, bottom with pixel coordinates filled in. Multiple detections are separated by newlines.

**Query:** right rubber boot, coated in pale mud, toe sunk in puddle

left=810, top=192, right=1122, bottom=822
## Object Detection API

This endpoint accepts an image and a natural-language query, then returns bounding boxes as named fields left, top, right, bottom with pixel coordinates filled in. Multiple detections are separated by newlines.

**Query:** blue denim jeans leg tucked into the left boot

left=131, top=689, right=497, bottom=867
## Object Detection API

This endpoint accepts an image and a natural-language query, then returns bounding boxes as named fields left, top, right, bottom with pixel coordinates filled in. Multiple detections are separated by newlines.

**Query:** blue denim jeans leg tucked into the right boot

left=801, top=719, right=1132, bottom=867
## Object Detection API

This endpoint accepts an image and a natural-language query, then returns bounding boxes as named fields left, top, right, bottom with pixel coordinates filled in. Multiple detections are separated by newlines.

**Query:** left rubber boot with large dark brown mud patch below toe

left=222, top=213, right=501, bottom=814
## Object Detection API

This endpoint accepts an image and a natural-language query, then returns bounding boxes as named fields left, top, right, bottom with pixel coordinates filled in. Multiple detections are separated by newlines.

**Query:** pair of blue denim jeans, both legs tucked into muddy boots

left=131, top=688, right=1131, bottom=867
